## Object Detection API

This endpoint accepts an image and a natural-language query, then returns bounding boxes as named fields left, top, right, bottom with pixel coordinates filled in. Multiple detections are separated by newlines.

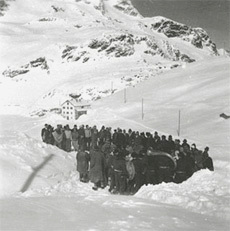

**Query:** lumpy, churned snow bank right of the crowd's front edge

left=135, top=167, right=230, bottom=219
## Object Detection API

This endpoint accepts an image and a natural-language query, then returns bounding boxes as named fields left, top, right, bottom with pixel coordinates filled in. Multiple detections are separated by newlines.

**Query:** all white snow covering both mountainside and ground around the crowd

left=0, top=0, right=230, bottom=231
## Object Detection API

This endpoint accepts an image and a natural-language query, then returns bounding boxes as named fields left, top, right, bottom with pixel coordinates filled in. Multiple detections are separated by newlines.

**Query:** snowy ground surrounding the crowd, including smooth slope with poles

left=0, top=55, right=230, bottom=230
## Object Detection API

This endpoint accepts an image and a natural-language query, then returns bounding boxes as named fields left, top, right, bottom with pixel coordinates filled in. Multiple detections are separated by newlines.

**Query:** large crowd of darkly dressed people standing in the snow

left=41, top=124, right=214, bottom=195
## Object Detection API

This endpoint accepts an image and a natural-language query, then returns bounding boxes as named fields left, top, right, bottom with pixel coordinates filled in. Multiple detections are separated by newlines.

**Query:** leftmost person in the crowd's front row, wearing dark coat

left=76, top=146, right=90, bottom=182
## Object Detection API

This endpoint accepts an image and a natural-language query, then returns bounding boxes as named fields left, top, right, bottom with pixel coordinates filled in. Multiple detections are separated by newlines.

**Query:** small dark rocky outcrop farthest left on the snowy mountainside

left=2, top=57, right=49, bottom=78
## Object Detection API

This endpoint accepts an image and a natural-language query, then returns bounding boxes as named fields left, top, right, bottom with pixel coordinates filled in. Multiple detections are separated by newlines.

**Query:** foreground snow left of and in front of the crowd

left=0, top=115, right=229, bottom=230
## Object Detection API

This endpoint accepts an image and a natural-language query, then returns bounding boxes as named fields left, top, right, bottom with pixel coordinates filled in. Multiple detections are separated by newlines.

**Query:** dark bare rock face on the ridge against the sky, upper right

left=151, top=18, right=218, bottom=55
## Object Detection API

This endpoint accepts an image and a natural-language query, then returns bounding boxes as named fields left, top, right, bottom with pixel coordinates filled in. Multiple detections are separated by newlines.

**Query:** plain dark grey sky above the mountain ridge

left=131, top=0, right=230, bottom=49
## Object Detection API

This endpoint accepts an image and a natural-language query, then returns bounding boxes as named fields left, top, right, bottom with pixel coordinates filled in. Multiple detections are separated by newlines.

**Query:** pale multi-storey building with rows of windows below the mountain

left=61, top=99, right=90, bottom=120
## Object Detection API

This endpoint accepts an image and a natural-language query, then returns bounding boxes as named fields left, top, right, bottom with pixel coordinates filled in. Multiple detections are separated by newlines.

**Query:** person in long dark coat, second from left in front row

left=89, top=145, right=105, bottom=190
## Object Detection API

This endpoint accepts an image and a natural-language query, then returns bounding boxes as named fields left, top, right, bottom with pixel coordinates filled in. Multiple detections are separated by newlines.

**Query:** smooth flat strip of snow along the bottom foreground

left=1, top=192, right=228, bottom=231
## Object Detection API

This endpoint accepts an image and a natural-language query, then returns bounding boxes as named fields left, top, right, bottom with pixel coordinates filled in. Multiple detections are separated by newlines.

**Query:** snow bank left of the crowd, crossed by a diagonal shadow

left=0, top=131, right=75, bottom=197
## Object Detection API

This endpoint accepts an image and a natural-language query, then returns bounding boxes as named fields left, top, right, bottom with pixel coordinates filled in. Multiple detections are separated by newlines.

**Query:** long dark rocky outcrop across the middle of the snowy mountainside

left=62, top=34, right=195, bottom=63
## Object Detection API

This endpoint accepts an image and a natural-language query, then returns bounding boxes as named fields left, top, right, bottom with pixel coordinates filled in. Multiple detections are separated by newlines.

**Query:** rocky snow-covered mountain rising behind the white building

left=0, top=0, right=223, bottom=111
